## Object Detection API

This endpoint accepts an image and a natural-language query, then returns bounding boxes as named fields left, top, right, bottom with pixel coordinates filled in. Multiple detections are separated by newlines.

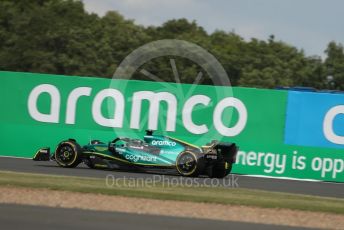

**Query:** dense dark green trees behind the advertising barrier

left=0, top=0, right=344, bottom=90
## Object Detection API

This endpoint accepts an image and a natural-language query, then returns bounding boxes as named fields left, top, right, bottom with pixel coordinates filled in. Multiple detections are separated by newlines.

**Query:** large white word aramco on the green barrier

left=28, top=84, right=247, bottom=137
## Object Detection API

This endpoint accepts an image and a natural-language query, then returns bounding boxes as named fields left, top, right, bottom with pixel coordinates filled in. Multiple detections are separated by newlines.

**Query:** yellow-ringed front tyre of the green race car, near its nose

left=54, top=141, right=81, bottom=168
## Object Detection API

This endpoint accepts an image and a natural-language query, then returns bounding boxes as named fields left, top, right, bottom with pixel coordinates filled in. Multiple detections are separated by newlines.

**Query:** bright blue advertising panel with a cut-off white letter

left=284, top=91, right=344, bottom=148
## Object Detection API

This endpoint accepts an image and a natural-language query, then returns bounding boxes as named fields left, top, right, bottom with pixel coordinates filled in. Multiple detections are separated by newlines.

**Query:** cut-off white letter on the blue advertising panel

left=323, top=105, right=344, bottom=145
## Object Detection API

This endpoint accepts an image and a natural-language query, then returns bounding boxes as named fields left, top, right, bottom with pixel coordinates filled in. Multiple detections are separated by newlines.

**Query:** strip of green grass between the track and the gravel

left=0, top=171, right=344, bottom=214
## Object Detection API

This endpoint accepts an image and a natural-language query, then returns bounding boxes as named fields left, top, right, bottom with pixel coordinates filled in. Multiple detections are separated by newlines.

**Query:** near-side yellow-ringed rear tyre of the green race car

left=176, top=151, right=203, bottom=177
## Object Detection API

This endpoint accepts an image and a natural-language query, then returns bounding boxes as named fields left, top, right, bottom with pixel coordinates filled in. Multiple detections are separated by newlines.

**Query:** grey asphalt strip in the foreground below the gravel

left=0, top=204, right=312, bottom=230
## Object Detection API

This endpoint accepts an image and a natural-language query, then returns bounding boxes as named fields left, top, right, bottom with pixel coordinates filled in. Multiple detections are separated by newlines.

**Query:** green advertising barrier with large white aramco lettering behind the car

left=0, top=72, right=344, bottom=182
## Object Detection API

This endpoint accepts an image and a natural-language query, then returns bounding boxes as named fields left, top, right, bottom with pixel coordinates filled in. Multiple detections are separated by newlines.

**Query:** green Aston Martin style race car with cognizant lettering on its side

left=33, top=130, right=238, bottom=178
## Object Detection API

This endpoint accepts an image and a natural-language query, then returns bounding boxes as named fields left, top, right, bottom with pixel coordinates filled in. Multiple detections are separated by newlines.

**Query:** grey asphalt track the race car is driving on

left=0, top=157, right=344, bottom=198
